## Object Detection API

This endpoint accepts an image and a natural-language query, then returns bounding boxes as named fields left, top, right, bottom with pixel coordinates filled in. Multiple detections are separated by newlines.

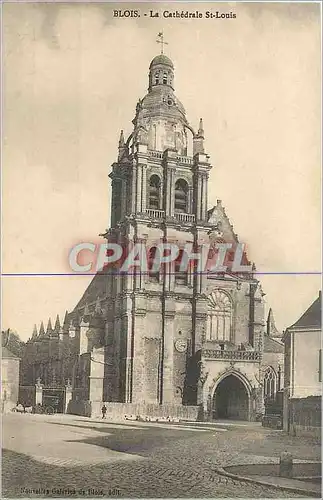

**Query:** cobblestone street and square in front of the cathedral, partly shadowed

left=2, top=414, right=320, bottom=498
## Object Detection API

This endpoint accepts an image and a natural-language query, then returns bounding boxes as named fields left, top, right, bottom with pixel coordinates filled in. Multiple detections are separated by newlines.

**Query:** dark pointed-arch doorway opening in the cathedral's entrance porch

left=213, top=374, right=250, bottom=420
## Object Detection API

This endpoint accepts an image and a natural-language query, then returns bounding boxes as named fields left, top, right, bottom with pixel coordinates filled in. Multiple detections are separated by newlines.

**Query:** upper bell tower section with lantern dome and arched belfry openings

left=110, top=54, right=211, bottom=227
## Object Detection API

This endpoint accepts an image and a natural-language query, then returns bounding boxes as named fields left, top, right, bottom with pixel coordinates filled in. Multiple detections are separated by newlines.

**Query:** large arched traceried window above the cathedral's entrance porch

left=207, top=290, right=232, bottom=342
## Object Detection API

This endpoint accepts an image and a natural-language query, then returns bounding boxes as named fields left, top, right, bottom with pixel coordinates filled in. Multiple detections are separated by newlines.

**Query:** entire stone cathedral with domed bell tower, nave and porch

left=22, top=53, right=283, bottom=420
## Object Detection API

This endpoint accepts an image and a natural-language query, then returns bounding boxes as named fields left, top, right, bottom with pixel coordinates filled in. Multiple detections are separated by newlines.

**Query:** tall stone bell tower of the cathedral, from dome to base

left=105, top=48, right=215, bottom=404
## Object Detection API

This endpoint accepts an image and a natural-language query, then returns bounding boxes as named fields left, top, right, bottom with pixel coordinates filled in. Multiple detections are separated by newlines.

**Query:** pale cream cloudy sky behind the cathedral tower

left=2, top=2, right=321, bottom=340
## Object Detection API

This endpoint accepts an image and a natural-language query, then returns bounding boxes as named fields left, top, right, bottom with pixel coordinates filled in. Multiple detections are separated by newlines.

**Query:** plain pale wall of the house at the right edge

left=290, top=330, right=322, bottom=398
